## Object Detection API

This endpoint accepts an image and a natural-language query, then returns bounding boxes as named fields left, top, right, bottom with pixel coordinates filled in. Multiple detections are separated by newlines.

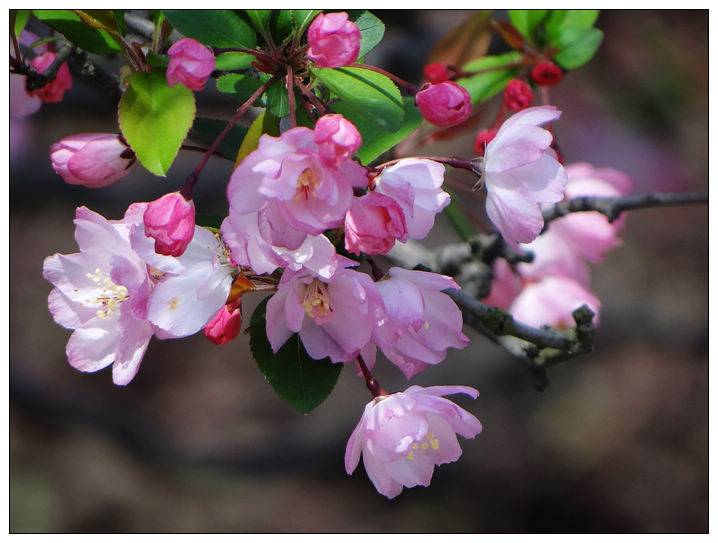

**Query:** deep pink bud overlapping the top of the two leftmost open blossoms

left=144, top=192, right=194, bottom=256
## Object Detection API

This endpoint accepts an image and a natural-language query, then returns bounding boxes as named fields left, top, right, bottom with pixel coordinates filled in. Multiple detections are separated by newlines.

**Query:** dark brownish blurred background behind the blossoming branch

left=9, top=10, right=708, bottom=532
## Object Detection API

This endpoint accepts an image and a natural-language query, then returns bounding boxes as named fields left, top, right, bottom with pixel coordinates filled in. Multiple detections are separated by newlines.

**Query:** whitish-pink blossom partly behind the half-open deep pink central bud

left=374, top=158, right=451, bottom=239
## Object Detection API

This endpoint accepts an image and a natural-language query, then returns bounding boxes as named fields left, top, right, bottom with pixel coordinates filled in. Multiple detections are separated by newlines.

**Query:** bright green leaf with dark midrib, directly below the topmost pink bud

left=315, top=68, right=404, bottom=132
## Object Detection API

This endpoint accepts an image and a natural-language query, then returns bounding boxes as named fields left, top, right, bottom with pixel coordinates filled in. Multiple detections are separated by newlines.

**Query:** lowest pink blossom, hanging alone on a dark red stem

left=344, top=385, right=481, bottom=499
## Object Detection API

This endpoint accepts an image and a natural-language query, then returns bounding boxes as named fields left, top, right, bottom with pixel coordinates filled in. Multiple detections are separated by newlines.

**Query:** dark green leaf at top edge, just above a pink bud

left=163, top=9, right=257, bottom=48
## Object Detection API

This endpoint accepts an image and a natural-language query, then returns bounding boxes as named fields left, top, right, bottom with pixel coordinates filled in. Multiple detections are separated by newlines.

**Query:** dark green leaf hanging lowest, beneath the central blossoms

left=249, top=298, right=344, bottom=413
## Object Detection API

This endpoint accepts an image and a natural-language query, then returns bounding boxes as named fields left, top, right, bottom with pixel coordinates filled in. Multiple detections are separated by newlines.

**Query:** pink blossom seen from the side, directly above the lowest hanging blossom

left=372, top=267, right=469, bottom=379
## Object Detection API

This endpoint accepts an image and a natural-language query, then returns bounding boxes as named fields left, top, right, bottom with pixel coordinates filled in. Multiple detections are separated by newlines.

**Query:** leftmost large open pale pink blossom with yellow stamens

left=43, top=207, right=154, bottom=385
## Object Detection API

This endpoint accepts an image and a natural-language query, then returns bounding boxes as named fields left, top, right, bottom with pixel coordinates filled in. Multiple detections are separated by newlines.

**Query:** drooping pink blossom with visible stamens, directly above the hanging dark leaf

left=267, top=257, right=384, bottom=362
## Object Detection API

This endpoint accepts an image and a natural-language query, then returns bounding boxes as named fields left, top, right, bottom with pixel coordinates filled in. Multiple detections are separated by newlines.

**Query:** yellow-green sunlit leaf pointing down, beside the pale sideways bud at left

left=119, top=69, right=195, bottom=177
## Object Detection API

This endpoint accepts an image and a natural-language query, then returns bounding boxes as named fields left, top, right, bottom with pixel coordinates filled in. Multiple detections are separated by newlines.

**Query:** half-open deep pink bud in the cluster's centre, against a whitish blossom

left=344, top=192, right=409, bottom=255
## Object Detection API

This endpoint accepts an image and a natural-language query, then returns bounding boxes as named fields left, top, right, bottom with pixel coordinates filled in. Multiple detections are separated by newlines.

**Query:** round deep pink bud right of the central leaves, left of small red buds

left=416, top=81, right=471, bottom=126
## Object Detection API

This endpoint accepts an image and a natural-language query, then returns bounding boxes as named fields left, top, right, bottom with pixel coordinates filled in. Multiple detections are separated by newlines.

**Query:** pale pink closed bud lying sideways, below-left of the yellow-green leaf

left=50, top=134, right=135, bottom=189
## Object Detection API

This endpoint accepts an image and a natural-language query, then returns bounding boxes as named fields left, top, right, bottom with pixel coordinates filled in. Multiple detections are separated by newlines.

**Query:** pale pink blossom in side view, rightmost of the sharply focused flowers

left=481, top=106, right=566, bottom=248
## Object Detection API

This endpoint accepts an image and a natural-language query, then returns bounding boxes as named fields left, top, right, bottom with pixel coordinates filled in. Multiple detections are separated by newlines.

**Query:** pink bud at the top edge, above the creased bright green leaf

left=307, top=12, right=361, bottom=68
